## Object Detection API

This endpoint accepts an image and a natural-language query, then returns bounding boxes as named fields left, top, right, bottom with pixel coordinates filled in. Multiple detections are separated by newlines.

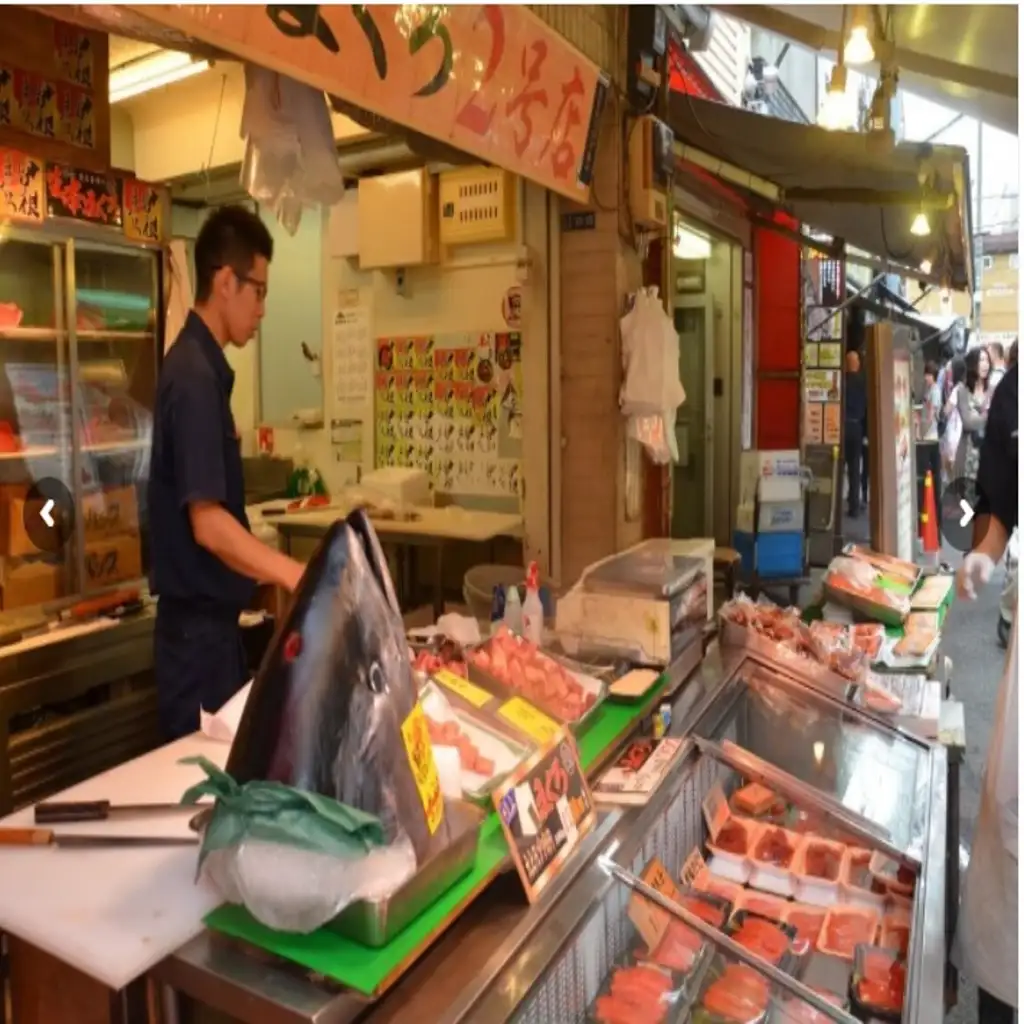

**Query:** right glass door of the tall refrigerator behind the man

left=68, top=241, right=160, bottom=593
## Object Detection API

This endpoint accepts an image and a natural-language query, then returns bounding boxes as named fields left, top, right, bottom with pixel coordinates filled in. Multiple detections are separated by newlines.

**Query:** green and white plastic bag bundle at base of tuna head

left=182, top=757, right=416, bottom=932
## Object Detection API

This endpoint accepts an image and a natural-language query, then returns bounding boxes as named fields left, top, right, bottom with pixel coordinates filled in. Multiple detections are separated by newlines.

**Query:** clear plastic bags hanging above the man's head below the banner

left=241, top=65, right=345, bottom=234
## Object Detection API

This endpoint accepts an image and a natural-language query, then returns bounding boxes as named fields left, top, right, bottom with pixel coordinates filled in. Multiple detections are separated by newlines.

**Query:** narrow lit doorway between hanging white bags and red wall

left=670, top=218, right=742, bottom=545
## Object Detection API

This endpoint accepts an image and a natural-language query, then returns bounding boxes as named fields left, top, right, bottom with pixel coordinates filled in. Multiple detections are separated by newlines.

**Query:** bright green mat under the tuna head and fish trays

left=206, top=676, right=667, bottom=995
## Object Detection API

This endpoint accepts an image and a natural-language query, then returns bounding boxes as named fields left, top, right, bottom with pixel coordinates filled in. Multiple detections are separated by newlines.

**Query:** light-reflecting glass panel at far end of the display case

left=694, top=660, right=931, bottom=857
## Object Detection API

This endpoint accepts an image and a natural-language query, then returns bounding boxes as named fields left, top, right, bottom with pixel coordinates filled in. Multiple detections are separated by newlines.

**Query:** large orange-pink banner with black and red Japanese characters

left=130, top=4, right=608, bottom=202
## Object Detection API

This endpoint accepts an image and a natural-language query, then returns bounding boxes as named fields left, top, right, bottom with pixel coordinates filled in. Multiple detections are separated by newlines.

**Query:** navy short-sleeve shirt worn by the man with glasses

left=150, top=311, right=254, bottom=610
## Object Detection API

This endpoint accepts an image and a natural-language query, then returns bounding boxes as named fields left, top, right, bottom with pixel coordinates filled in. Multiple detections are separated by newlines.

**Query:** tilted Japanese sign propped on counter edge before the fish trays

left=492, top=729, right=597, bottom=903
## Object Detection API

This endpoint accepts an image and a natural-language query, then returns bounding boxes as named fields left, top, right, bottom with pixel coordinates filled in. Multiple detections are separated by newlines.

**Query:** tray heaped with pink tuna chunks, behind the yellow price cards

left=469, top=630, right=606, bottom=730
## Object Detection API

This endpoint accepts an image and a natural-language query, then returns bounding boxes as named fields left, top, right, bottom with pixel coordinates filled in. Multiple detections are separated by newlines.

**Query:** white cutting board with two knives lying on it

left=0, top=733, right=230, bottom=989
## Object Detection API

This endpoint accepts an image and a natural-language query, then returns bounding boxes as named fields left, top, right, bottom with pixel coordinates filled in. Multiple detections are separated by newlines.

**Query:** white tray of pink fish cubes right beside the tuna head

left=420, top=682, right=530, bottom=803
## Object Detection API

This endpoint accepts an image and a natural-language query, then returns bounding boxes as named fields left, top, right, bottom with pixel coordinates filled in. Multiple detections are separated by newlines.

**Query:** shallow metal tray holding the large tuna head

left=327, top=801, right=485, bottom=949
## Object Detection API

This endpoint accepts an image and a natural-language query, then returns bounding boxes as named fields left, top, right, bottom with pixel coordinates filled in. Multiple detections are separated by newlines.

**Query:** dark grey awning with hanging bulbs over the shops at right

left=669, top=94, right=974, bottom=291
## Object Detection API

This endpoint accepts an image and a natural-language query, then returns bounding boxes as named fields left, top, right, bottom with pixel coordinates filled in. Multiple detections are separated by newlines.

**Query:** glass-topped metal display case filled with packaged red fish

left=475, top=656, right=947, bottom=1024
